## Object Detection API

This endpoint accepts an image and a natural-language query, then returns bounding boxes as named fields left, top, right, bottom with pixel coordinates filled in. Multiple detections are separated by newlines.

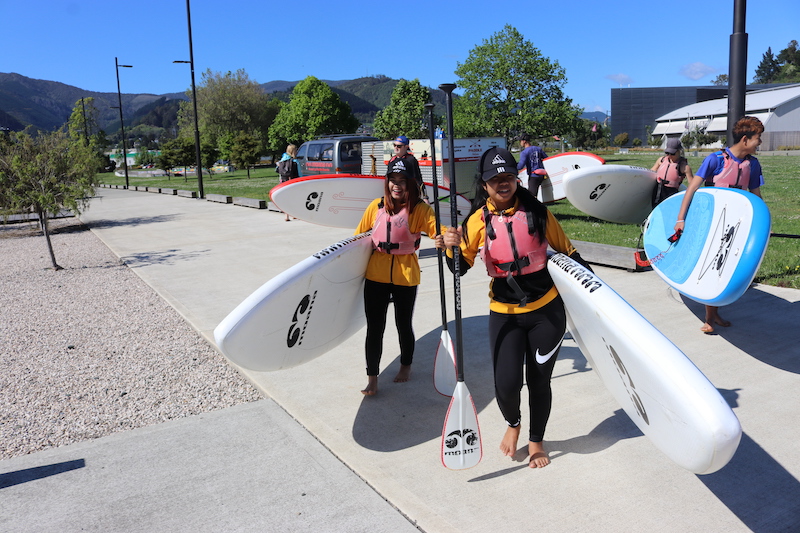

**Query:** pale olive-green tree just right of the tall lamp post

left=178, top=69, right=280, bottom=154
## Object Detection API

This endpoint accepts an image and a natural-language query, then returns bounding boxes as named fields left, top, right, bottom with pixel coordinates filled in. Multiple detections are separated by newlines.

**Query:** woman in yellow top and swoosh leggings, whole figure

left=436, top=147, right=591, bottom=468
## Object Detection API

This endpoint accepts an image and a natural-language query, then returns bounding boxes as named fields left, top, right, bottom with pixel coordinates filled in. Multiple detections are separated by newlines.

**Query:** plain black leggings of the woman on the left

left=364, top=280, right=417, bottom=376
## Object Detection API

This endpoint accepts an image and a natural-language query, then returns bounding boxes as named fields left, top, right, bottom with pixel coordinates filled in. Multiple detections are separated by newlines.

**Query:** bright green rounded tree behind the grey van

left=269, top=76, right=359, bottom=152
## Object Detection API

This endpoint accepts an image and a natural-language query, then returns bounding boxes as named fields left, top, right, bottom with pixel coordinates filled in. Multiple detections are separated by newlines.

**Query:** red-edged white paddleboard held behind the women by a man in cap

left=270, top=174, right=470, bottom=229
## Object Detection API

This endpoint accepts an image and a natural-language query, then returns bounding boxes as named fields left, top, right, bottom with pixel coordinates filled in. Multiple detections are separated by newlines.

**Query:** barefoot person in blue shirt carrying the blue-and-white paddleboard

left=675, top=117, right=764, bottom=333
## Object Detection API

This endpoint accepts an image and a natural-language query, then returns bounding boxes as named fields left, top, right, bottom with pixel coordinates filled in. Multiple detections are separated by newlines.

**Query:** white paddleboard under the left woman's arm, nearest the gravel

left=214, top=232, right=372, bottom=371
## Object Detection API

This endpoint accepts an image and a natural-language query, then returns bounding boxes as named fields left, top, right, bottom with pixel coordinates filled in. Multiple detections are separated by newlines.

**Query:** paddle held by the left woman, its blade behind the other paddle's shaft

left=425, top=104, right=456, bottom=396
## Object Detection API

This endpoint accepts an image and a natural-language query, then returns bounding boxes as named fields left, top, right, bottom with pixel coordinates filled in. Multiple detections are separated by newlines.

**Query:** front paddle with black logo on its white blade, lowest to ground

left=434, top=83, right=483, bottom=470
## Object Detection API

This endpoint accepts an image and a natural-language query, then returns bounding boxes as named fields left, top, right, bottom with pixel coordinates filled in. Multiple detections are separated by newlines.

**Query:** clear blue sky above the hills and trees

left=0, top=0, right=800, bottom=111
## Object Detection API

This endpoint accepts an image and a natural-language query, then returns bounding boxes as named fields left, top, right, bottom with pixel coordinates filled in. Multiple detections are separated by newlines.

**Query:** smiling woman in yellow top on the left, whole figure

left=356, top=159, right=444, bottom=396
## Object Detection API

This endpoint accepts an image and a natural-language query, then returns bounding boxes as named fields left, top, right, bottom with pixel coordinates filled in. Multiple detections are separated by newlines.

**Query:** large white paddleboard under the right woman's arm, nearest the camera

left=547, top=254, right=742, bottom=474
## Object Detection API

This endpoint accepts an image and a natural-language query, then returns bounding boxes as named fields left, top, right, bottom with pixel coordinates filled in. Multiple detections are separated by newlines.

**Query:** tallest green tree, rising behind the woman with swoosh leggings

left=453, top=25, right=581, bottom=144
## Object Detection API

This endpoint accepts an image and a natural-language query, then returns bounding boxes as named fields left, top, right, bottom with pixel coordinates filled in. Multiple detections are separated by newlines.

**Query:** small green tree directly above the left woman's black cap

left=374, top=79, right=431, bottom=139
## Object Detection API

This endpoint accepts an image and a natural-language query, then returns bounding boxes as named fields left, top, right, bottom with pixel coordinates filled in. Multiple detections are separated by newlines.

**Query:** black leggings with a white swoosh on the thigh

left=489, top=296, right=567, bottom=442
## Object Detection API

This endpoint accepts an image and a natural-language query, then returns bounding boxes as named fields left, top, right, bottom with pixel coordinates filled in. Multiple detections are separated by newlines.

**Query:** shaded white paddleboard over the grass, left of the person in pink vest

left=564, top=165, right=656, bottom=224
